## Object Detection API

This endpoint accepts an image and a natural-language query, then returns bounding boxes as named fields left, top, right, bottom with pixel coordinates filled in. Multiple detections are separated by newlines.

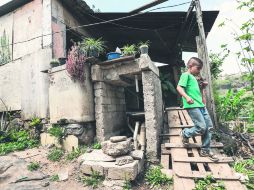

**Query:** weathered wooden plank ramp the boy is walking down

left=160, top=107, right=246, bottom=190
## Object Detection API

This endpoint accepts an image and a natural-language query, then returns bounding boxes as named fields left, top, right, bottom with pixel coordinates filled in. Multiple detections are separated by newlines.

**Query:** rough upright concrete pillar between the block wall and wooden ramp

left=142, top=71, right=163, bottom=161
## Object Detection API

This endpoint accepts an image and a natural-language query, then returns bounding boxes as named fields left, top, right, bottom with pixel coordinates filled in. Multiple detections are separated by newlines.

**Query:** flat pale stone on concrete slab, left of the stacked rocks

left=81, top=149, right=116, bottom=162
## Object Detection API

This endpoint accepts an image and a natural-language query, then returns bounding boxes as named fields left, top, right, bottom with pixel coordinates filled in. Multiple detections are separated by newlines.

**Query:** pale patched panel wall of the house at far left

left=0, top=0, right=52, bottom=119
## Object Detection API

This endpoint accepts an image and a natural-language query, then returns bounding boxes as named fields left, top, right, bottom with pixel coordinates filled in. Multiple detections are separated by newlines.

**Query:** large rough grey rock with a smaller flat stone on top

left=102, top=139, right=131, bottom=157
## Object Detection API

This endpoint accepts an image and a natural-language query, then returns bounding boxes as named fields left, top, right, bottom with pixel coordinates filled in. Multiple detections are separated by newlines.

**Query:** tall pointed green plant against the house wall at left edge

left=0, top=30, right=11, bottom=65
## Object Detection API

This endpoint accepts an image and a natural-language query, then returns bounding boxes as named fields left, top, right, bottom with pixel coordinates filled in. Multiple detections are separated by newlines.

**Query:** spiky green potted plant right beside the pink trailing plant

left=80, top=38, right=105, bottom=57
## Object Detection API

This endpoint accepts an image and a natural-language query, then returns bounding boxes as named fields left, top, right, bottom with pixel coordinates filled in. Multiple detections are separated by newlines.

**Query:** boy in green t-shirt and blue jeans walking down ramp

left=177, top=57, right=219, bottom=162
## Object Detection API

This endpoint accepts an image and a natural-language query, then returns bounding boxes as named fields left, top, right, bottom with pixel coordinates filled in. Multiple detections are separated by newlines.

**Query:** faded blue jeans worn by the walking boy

left=183, top=107, right=213, bottom=151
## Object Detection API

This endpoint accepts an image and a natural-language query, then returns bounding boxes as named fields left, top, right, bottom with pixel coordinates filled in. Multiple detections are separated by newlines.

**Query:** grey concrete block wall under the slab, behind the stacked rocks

left=94, top=82, right=127, bottom=142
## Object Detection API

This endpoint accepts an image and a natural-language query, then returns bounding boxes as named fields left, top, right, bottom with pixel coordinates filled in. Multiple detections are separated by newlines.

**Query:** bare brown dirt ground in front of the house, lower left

left=0, top=147, right=173, bottom=190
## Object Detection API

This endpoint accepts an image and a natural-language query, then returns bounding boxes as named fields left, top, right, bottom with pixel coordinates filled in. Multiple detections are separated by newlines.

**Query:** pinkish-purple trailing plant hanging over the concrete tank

left=66, top=44, right=87, bottom=82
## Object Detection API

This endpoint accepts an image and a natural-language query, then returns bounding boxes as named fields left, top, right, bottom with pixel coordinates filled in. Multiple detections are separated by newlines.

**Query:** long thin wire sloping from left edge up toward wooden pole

left=0, top=1, right=191, bottom=48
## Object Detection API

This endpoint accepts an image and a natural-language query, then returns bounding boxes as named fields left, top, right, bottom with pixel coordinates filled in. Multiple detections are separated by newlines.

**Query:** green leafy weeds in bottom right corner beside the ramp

left=233, top=157, right=254, bottom=190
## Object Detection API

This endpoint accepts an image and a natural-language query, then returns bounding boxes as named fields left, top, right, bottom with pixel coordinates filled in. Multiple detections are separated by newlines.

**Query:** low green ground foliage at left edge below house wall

left=0, top=129, right=39, bottom=155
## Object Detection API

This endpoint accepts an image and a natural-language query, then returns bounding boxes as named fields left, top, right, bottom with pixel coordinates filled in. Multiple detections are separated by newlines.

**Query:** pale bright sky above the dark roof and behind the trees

left=86, top=0, right=253, bottom=74
